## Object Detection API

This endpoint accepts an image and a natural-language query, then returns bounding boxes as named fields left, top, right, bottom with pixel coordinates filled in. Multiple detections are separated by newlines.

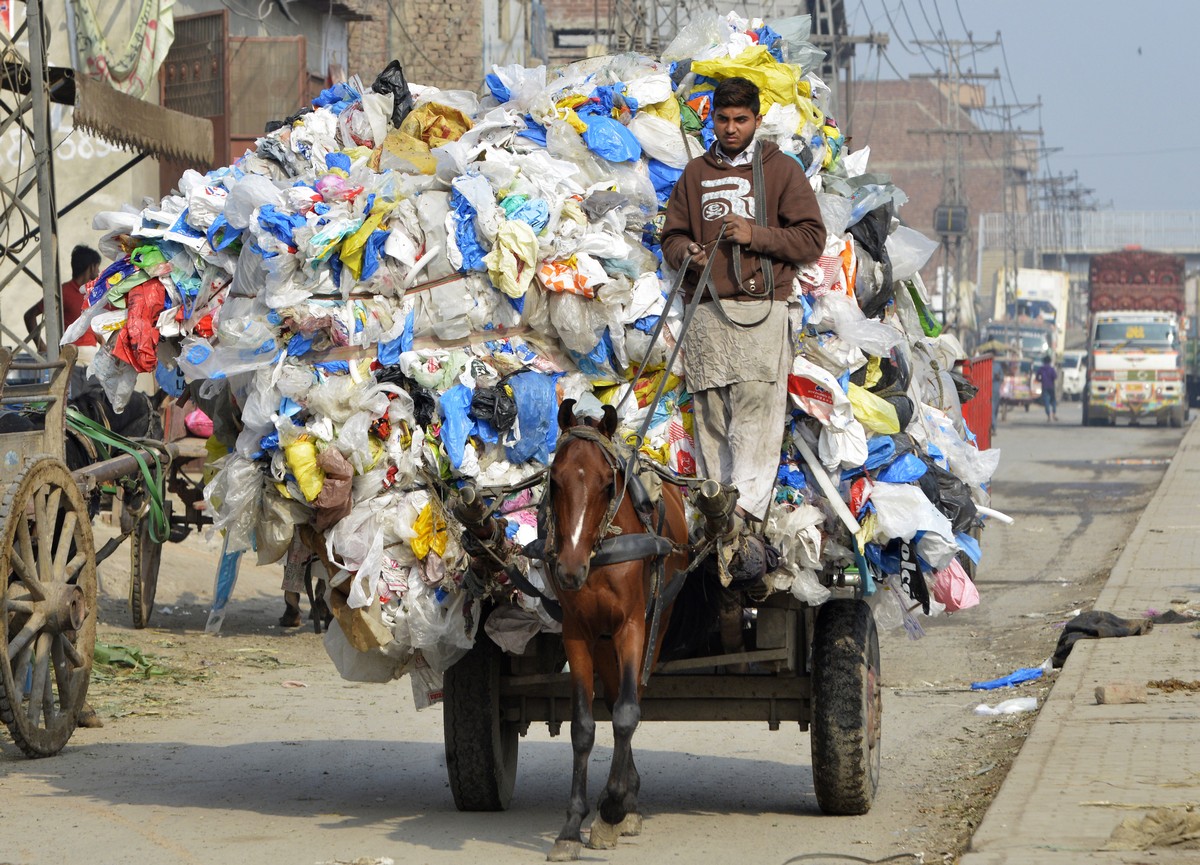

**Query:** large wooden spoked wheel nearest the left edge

left=0, top=456, right=96, bottom=757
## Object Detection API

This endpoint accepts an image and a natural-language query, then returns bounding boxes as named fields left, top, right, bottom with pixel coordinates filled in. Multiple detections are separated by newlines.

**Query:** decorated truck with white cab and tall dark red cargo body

left=1082, top=250, right=1187, bottom=427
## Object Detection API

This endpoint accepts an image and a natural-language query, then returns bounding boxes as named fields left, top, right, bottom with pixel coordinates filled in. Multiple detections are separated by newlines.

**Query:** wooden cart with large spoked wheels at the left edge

left=0, top=346, right=187, bottom=757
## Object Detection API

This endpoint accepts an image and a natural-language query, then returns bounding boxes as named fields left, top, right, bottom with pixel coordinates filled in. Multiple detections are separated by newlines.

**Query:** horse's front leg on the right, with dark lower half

left=588, top=620, right=646, bottom=849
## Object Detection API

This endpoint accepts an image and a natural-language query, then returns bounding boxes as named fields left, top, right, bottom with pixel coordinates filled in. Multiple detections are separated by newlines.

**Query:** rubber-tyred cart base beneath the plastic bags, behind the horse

left=443, top=575, right=882, bottom=815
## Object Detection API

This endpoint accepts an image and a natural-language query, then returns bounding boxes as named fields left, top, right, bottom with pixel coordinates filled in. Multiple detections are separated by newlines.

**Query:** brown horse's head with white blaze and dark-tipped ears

left=547, top=400, right=620, bottom=590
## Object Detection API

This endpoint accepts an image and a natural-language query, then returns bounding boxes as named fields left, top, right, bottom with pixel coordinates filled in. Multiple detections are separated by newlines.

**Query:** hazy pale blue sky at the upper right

left=846, top=0, right=1200, bottom=210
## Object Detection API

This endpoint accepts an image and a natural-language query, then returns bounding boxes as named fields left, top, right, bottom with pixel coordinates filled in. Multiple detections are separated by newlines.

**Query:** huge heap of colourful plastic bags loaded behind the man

left=75, top=14, right=998, bottom=683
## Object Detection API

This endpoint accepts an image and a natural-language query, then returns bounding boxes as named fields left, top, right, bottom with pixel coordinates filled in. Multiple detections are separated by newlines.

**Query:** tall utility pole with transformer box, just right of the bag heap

left=912, top=34, right=1000, bottom=334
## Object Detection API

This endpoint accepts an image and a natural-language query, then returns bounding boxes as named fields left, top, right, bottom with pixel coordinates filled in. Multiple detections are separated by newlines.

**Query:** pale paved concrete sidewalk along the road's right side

left=960, top=422, right=1200, bottom=865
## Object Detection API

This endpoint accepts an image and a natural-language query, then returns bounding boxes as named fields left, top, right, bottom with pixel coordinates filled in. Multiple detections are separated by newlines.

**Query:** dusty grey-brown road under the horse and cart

left=0, top=406, right=1180, bottom=865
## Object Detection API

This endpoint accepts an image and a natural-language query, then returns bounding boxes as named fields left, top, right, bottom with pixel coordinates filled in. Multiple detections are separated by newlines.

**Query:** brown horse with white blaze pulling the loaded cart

left=546, top=401, right=688, bottom=861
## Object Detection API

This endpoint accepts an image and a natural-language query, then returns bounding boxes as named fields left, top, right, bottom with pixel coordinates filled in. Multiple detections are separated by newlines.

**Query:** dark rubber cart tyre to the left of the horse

left=443, top=633, right=520, bottom=811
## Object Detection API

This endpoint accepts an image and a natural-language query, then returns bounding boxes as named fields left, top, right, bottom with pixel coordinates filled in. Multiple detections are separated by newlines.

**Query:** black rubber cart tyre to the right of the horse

left=811, top=599, right=883, bottom=815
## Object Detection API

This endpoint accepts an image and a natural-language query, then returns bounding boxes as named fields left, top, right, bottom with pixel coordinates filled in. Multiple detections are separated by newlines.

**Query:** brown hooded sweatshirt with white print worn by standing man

left=662, top=142, right=826, bottom=302
